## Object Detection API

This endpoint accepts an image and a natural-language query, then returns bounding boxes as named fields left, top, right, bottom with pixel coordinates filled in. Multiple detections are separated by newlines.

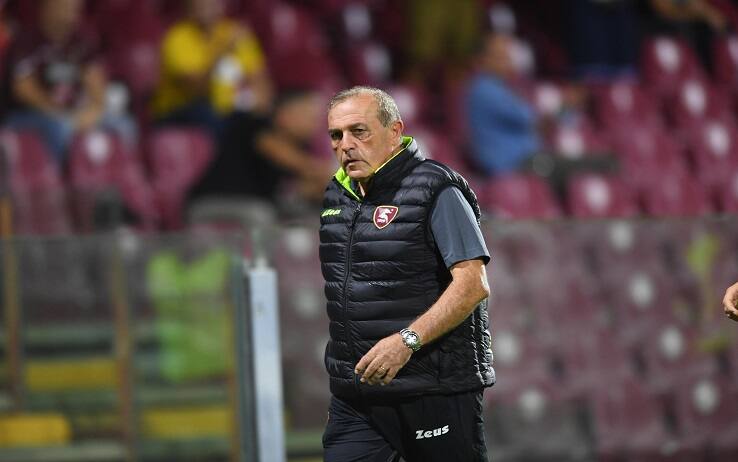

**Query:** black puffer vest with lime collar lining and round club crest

left=320, top=137, right=495, bottom=398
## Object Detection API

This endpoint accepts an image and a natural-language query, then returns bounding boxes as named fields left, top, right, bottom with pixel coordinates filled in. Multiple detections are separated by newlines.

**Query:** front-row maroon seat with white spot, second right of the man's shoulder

left=568, top=174, right=638, bottom=218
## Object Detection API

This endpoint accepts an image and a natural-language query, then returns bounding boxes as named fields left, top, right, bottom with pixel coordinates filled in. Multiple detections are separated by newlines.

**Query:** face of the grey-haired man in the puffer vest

left=328, top=95, right=403, bottom=182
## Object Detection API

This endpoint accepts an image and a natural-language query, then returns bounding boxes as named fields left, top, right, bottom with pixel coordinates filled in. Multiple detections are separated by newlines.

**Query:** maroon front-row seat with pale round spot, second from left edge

left=69, top=131, right=159, bottom=232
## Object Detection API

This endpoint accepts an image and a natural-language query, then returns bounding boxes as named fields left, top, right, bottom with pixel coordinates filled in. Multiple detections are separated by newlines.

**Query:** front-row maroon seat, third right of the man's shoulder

left=643, top=176, right=712, bottom=217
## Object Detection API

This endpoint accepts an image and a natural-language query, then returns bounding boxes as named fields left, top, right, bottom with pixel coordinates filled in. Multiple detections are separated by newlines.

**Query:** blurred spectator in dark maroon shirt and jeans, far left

left=2, top=0, right=137, bottom=162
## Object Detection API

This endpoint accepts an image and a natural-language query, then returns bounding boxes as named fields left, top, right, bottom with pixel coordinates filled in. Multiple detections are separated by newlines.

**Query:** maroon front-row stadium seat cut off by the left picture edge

left=0, top=130, right=72, bottom=234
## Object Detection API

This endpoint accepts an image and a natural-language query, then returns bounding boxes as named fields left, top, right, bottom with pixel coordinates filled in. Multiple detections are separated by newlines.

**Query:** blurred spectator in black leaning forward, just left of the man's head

left=185, top=90, right=334, bottom=226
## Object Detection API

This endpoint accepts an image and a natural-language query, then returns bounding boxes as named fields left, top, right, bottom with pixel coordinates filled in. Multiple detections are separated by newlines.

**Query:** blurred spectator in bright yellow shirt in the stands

left=153, top=0, right=271, bottom=134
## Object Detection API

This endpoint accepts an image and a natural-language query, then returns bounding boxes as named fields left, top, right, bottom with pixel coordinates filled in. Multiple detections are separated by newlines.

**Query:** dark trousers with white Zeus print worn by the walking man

left=323, top=391, right=487, bottom=462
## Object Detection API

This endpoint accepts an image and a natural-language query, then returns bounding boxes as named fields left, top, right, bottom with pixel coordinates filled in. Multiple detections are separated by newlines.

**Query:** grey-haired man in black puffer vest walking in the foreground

left=320, top=87, right=495, bottom=462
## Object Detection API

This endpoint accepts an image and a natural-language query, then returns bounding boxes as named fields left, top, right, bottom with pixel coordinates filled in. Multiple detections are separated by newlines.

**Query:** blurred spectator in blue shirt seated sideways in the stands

left=466, top=34, right=539, bottom=175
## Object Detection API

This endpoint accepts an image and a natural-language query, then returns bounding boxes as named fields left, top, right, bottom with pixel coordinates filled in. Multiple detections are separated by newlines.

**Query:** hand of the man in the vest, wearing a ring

left=354, top=334, right=413, bottom=386
